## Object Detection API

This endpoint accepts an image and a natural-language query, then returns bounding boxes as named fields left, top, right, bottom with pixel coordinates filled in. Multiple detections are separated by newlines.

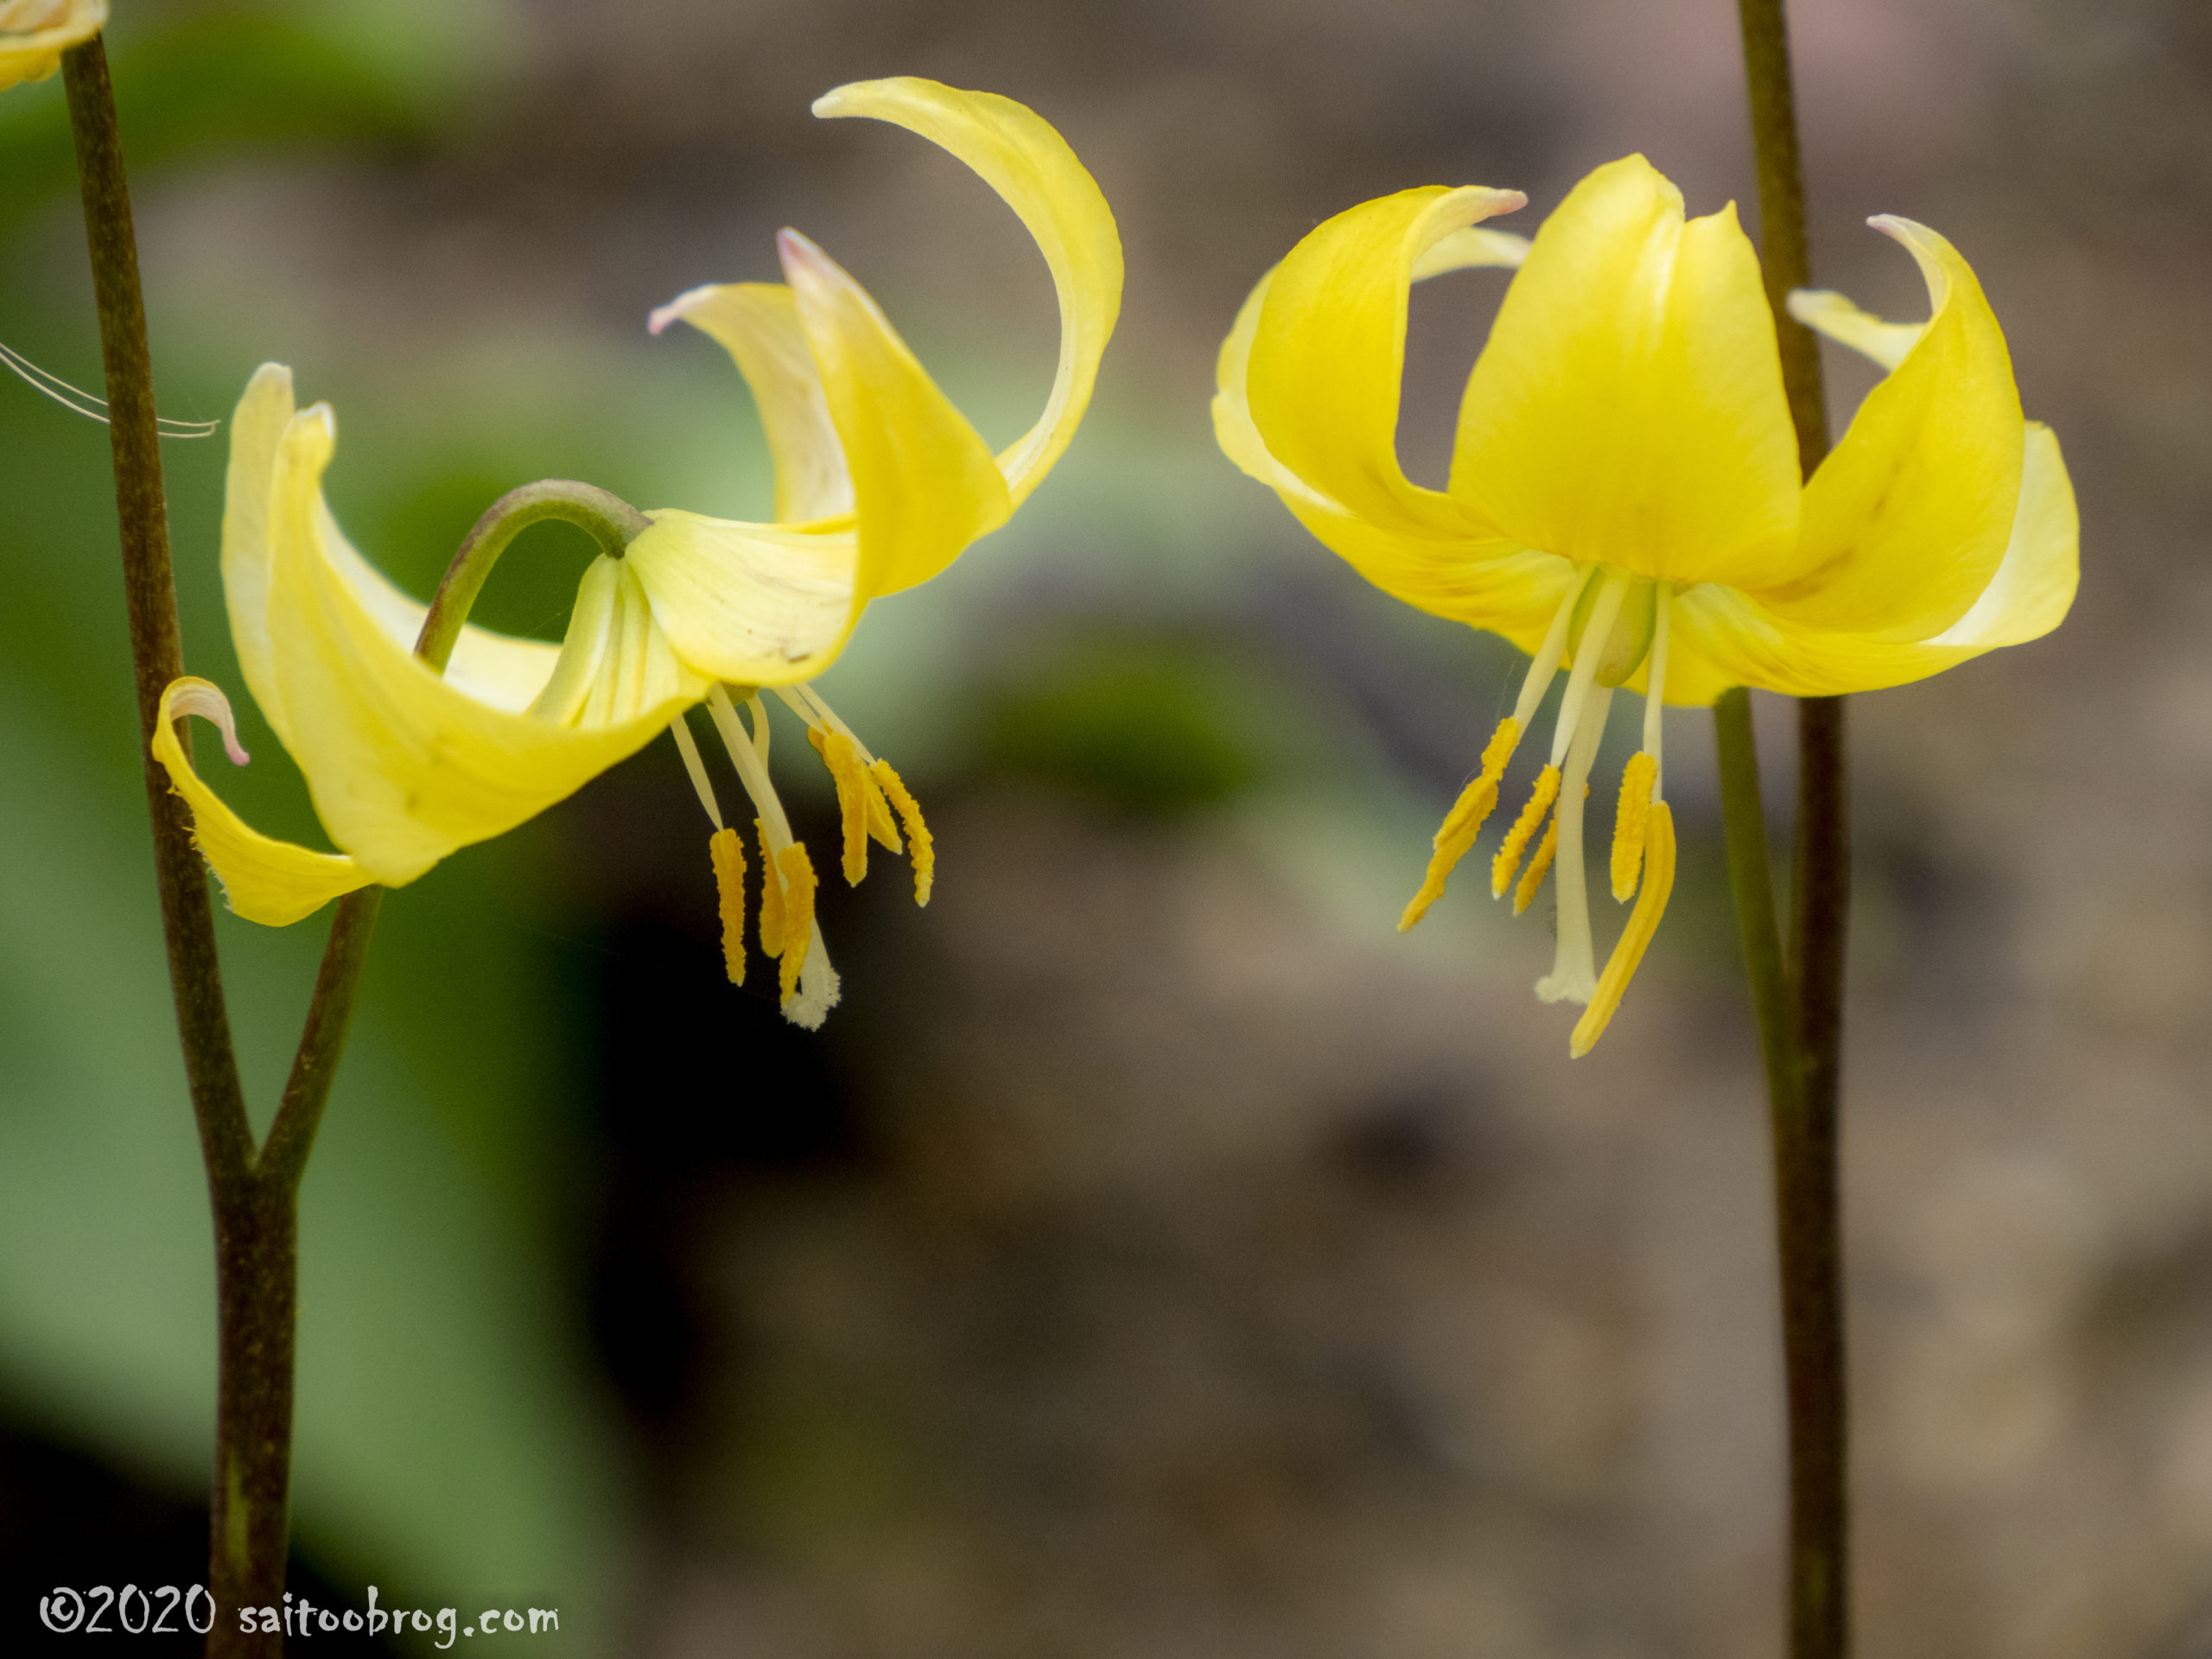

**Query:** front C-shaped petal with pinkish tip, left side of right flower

left=1256, top=186, right=1526, bottom=546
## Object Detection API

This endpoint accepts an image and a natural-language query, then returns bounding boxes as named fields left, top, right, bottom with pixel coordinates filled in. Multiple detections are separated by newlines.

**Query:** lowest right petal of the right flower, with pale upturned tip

left=1668, top=423, right=2082, bottom=703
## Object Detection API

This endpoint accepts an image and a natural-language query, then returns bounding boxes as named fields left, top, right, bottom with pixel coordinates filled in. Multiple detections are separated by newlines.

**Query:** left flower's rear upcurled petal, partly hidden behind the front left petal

left=224, top=363, right=560, bottom=721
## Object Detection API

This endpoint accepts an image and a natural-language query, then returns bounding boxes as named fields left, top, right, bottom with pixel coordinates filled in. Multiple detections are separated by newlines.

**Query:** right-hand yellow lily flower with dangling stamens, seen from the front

left=1214, top=155, right=2079, bottom=1055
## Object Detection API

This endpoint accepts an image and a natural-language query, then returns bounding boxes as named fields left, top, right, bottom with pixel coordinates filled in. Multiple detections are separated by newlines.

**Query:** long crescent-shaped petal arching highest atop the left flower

left=814, top=75, right=1122, bottom=506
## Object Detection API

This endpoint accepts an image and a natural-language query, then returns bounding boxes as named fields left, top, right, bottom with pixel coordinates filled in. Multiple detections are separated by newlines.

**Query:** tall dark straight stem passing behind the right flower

left=1738, top=0, right=1852, bottom=1659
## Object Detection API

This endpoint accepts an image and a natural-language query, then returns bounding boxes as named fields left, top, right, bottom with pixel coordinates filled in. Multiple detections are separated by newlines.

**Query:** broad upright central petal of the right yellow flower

left=1451, top=155, right=1798, bottom=582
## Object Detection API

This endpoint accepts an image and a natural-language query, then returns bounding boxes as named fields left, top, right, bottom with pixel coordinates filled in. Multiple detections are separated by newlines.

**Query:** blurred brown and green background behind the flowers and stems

left=0, top=0, right=2212, bottom=1659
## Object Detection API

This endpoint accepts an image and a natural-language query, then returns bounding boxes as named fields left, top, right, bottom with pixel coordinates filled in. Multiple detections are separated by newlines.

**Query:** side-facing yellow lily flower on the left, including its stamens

left=155, top=79, right=1122, bottom=1027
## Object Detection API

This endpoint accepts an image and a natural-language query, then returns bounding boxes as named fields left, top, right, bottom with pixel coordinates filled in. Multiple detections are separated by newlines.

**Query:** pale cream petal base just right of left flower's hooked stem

left=621, top=509, right=861, bottom=686
